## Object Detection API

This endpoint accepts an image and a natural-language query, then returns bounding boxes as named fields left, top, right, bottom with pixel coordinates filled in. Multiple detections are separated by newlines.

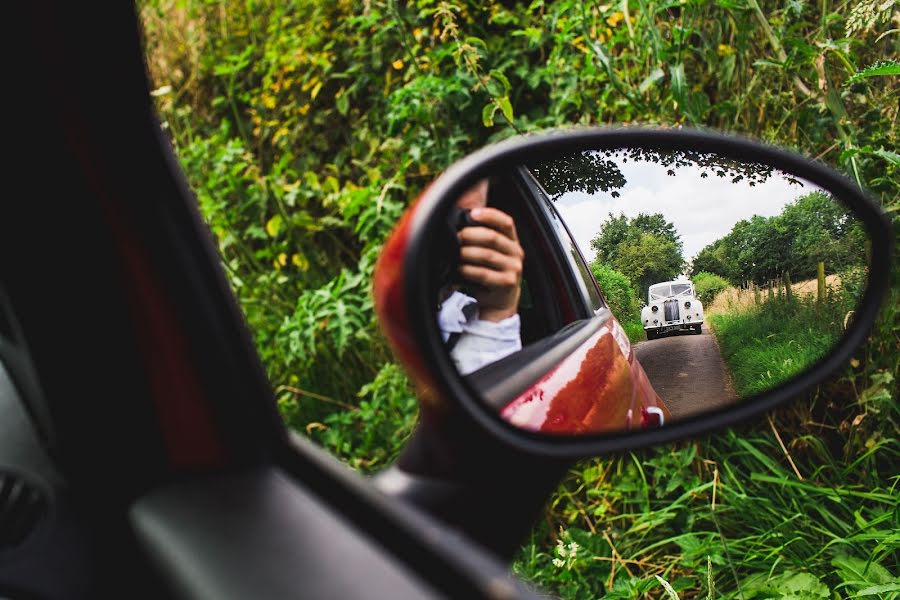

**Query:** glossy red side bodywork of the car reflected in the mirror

left=500, top=318, right=670, bottom=435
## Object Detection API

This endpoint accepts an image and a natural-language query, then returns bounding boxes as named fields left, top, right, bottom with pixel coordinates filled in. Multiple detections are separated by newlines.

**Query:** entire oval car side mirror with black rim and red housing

left=375, top=128, right=891, bottom=458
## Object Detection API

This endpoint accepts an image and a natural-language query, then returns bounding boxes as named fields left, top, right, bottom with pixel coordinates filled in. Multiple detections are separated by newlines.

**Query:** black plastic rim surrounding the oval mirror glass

left=376, top=127, right=892, bottom=459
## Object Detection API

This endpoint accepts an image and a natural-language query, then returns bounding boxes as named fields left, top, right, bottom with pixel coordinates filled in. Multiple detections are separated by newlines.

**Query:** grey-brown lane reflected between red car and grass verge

left=634, top=325, right=736, bottom=419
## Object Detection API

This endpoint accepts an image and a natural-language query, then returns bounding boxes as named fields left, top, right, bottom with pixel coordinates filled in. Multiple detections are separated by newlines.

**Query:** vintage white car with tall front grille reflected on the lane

left=641, top=279, right=703, bottom=340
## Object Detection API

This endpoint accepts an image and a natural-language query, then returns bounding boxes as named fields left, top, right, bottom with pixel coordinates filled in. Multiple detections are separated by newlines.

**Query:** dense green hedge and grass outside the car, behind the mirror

left=139, top=0, right=900, bottom=598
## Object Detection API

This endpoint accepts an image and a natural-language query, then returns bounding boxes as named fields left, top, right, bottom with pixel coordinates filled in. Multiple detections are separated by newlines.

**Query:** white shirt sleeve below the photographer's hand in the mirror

left=438, top=292, right=522, bottom=375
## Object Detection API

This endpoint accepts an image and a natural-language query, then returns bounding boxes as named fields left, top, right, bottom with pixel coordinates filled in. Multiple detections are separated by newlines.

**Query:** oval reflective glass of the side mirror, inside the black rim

left=434, top=147, right=868, bottom=435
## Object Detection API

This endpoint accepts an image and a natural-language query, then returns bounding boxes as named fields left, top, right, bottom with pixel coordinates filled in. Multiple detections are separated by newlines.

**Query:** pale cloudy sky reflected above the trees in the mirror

left=554, top=159, right=819, bottom=260
